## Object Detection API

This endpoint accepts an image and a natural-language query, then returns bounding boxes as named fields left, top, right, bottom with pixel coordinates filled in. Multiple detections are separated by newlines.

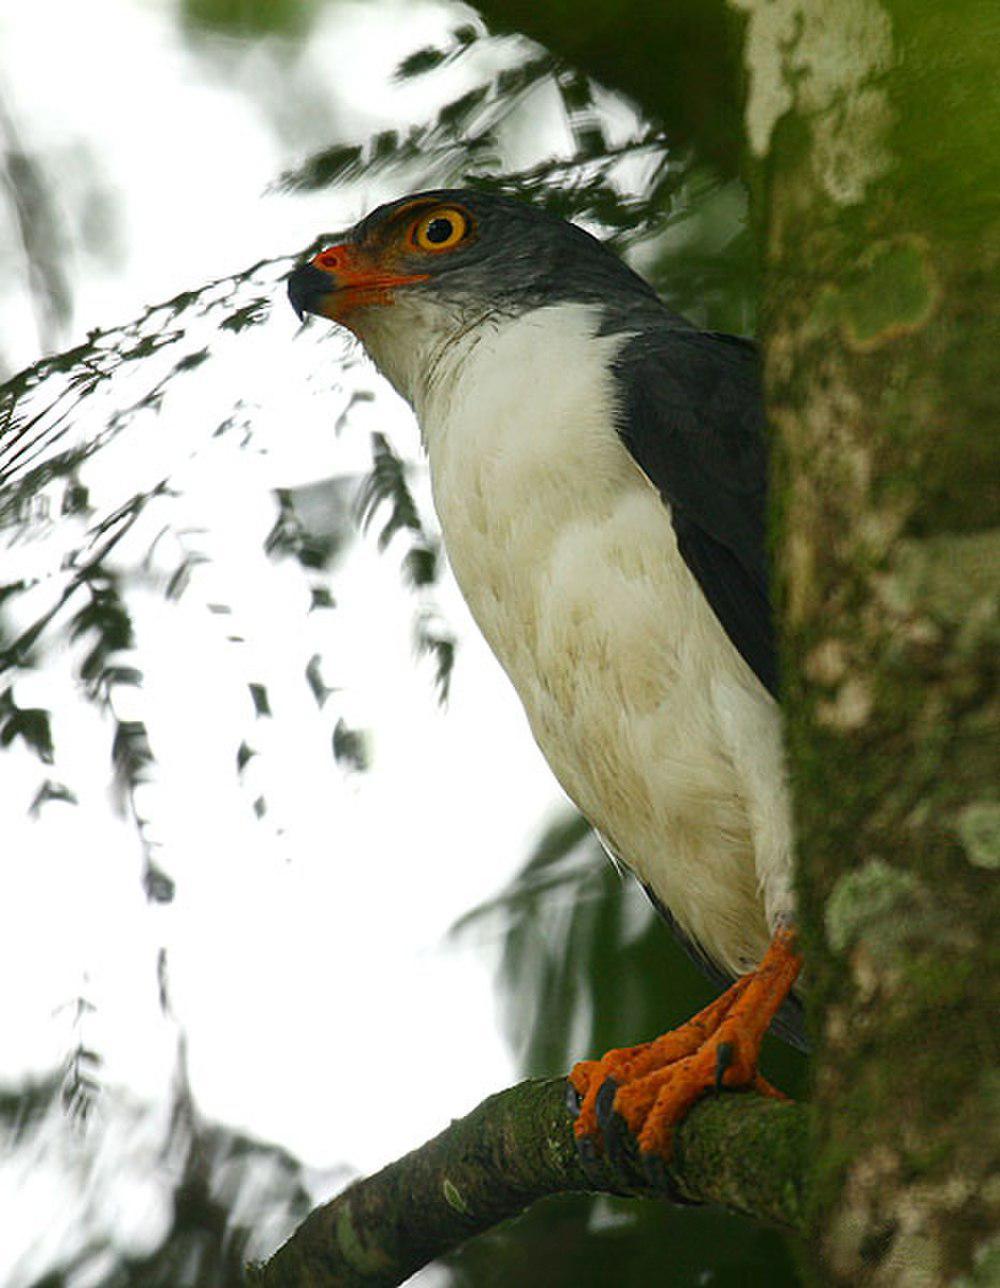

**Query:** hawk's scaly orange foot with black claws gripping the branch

left=570, top=929, right=802, bottom=1164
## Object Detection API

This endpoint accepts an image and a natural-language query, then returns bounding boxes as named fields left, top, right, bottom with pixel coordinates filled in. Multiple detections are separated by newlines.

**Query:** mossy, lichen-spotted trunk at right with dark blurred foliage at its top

left=481, top=0, right=1000, bottom=1285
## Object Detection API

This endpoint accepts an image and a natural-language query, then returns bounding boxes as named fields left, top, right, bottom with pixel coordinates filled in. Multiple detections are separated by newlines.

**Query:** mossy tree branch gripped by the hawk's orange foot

left=247, top=1078, right=807, bottom=1288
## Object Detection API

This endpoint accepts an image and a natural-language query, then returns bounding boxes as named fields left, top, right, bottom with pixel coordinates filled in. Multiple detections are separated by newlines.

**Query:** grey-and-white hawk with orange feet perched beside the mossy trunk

left=289, top=189, right=803, bottom=1164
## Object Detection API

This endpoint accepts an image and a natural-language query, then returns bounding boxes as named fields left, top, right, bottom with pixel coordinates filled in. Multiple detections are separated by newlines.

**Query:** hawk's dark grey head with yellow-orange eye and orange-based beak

left=289, top=188, right=661, bottom=402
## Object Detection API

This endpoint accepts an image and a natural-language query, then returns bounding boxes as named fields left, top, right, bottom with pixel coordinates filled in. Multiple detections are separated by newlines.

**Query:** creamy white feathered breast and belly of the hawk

left=416, top=305, right=789, bottom=972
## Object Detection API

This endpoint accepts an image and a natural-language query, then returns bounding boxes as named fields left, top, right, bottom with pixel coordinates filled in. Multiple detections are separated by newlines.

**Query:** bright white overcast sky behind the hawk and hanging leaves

left=0, top=0, right=634, bottom=1288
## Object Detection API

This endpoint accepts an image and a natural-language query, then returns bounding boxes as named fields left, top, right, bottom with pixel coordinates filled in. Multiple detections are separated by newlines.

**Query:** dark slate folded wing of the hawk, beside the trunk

left=615, top=326, right=778, bottom=697
